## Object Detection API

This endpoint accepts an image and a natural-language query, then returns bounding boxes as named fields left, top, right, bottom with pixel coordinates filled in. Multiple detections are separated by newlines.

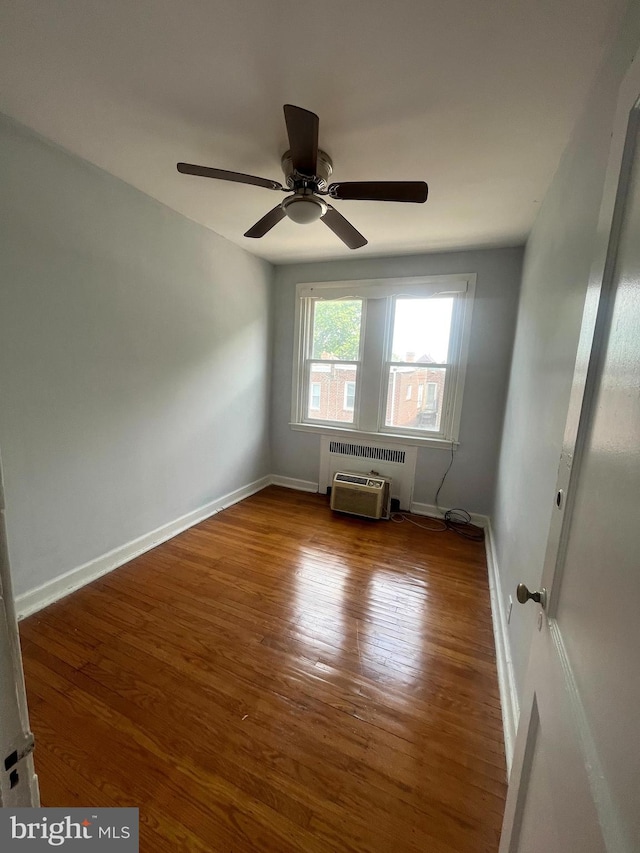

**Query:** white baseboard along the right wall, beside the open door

left=484, top=519, right=520, bottom=776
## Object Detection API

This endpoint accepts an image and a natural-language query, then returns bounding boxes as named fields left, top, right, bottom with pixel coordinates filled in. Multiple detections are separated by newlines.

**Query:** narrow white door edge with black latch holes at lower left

left=0, top=452, right=39, bottom=807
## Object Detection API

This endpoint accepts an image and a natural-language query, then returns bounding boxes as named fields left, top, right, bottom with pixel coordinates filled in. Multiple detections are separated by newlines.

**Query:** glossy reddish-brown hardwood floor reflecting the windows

left=20, top=487, right=506, bottom=853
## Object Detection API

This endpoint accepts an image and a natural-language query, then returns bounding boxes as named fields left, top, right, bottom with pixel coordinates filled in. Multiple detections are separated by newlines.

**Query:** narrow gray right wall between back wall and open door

left=492, top=2, right=640, bottom=695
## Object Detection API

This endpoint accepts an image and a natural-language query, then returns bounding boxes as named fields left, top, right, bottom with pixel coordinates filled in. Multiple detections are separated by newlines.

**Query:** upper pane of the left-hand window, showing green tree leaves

left=311, top=299, right=362, bottom=361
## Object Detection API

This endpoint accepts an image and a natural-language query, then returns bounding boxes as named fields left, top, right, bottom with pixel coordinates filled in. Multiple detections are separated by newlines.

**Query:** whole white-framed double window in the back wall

left=292, top=275, right=475, bottom=442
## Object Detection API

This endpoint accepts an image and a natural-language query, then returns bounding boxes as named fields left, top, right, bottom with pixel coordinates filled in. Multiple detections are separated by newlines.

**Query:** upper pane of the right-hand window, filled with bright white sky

left=391, top=296, right=454, bottom=364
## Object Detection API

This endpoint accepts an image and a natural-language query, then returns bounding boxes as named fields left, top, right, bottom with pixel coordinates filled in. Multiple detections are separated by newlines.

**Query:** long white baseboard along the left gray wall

left=15, top=477, right=271, bottom=619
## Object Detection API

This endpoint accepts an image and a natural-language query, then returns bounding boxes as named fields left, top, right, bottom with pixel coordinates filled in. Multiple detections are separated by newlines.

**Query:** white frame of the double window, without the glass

left=290, top=273, right=476, bottom=447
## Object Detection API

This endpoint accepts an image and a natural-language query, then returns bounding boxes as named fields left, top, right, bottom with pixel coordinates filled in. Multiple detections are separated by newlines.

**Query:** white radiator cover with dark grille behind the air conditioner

left=318, top=435, right=418, bottom=511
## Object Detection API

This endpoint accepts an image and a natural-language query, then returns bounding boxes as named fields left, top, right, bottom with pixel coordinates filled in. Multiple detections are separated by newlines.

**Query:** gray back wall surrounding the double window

left=271, top=249, right=522, bottom=513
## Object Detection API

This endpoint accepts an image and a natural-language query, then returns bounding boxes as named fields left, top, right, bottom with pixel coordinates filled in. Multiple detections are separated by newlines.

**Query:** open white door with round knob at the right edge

left=500, top=54, right=640, bottom=853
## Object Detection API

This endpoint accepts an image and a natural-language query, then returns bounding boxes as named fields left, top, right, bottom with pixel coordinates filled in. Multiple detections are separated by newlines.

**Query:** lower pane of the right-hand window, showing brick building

left=385, top=364, right=447, bottom=432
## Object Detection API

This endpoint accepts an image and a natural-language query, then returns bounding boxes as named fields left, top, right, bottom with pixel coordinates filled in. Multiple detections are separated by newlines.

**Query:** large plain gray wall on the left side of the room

left=0, top=113, right=273, bottom=594
